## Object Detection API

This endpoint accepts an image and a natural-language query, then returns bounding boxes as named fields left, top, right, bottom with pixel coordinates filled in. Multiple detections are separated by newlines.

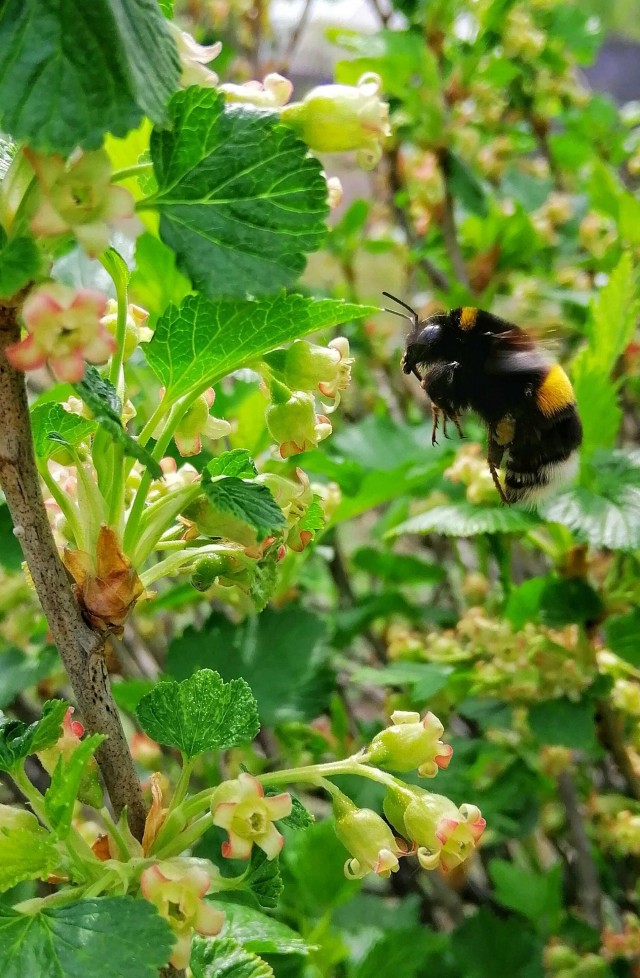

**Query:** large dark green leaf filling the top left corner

left=0, top=0, right=181, bottom=156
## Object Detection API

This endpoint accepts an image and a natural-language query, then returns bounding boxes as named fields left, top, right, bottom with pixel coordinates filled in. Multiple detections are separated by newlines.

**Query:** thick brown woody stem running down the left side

left=0, top=297, right=146, bottom=838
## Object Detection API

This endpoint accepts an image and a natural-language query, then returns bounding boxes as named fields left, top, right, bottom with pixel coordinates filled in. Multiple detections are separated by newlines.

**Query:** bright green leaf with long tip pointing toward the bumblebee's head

left=145, top=295, right=378, bottom=402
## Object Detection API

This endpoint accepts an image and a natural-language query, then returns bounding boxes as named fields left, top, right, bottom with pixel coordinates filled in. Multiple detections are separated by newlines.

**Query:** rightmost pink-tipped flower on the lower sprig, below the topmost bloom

left=384, top=785, right=486, bottom=873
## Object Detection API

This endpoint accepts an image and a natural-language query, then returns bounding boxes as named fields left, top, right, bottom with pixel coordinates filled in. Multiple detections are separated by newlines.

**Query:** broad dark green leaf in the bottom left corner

left=0, top=896, right=175, bottom=978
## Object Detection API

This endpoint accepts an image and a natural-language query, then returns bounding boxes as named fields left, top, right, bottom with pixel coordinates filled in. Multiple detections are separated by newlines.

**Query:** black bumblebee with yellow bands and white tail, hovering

left=382, top=292, right=582, bottom=506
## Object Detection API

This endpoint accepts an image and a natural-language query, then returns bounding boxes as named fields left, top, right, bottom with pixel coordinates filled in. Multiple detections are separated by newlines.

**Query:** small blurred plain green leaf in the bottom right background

left=489, top=859, right=562, bottom=933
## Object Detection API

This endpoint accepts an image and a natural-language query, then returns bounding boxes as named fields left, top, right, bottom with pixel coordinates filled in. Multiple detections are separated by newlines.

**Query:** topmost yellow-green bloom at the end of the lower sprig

left=363, top=710, right=453, bottom=778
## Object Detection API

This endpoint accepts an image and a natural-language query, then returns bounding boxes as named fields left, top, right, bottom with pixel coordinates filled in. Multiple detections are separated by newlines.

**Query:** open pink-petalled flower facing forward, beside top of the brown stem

left=7, top=282, right=116, bottom=384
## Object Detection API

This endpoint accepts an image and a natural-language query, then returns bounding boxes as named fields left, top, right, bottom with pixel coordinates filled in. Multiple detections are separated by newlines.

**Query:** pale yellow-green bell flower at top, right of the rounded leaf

left=280, top=72, right=391, bottom=167
